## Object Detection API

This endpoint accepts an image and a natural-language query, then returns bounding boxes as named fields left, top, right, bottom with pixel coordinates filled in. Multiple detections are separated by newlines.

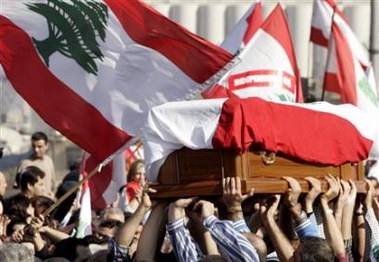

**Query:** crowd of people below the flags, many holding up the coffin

left=0, top=133, right=379, bottom=262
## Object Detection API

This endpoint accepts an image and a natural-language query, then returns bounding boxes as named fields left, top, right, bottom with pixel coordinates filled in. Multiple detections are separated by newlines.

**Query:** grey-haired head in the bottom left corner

left=0, top=243, right=34, bottom=262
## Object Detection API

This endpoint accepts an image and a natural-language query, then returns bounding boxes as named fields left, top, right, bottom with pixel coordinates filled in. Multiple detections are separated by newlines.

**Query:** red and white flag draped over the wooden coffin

left=143, top=97, right=379, bottom=181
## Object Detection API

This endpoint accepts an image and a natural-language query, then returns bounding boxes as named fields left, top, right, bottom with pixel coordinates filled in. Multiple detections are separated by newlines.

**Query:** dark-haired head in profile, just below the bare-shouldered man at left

left=19, top=166, right=45, bottom=197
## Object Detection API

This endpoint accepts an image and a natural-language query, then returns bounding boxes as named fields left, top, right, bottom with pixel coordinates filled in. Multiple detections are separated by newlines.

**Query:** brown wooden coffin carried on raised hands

left=155, top=148, right=365, bottom=198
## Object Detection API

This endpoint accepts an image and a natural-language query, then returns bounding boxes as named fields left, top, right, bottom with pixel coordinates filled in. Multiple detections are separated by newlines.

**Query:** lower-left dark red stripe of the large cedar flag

left=0, top=16, right=130, bottom=159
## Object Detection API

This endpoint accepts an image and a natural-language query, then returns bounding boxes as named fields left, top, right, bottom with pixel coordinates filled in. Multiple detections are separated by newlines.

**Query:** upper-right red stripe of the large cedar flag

left=105, top=0, right=232, bottom=83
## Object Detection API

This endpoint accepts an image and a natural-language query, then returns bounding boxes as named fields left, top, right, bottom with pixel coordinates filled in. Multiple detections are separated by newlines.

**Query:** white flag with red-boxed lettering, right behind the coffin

left=202, top=4, right=303, bottom=102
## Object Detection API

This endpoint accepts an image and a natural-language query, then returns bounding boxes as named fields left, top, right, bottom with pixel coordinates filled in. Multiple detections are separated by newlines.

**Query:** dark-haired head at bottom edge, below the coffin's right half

left=294, top=237, right=334, bottom=262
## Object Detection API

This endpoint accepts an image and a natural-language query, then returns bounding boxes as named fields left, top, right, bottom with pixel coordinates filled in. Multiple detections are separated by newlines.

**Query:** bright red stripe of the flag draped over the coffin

left=212, top=98, right=372, bottom=165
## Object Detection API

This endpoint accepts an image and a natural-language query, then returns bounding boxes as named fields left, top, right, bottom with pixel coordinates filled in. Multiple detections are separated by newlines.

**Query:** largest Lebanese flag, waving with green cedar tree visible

left=0, top=0, right=232, bottom=161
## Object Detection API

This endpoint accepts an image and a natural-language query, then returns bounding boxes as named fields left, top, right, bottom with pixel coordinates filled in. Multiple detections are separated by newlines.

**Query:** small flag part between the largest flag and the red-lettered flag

left=220, top=0, right=263, bottom=54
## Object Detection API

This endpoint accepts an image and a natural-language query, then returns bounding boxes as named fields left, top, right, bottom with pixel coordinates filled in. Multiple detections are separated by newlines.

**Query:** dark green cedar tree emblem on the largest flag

left=27, top=0, right=108, bottom=75
